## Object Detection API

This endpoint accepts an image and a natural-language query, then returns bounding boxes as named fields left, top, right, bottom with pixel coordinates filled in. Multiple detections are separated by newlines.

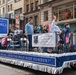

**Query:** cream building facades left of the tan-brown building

left=0, top=0, right=25, bottom=29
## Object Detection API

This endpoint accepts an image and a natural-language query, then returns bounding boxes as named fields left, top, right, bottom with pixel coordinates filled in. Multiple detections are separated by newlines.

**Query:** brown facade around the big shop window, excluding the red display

left=52, top=0, right=76, bottom=32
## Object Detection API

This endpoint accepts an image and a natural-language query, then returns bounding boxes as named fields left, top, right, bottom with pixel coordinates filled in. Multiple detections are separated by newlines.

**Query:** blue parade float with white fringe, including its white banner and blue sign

left=0, top=19, right=76, bottom=74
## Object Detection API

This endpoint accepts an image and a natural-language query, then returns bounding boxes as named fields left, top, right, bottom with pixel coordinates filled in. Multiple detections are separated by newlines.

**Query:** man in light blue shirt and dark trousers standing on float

left=25, top=18, right=34, bottom=51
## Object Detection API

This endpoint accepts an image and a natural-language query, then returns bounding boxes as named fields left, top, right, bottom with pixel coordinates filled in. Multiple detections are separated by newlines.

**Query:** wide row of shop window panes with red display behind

left=53, top=6, right=76, bottom=21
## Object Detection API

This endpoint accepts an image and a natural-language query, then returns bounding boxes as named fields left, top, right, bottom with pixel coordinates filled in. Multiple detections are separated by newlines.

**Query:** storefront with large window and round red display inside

left=52, top=1, right=76, bottom=32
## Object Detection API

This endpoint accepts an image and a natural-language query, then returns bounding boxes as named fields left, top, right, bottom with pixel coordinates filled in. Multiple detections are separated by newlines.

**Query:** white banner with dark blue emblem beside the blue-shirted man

left=32, top=33, right=56, bottom=47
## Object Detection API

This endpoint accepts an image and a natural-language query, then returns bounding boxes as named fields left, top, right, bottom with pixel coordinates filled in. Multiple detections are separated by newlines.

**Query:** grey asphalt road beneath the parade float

left=0, top=63, right=76, bottom=75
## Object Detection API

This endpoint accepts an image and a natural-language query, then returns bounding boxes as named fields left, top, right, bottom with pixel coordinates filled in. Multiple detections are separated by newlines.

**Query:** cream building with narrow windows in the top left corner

left=0, top=0, right=14, bottom=17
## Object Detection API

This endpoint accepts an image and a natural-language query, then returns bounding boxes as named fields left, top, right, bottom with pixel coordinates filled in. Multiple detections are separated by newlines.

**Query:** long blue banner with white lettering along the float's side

left=0, top=52, right=56, bottom=67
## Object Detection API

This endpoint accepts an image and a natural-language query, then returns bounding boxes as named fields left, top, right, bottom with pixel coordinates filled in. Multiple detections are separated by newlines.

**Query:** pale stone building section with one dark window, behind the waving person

left=39, top=0, right=52, bottom=25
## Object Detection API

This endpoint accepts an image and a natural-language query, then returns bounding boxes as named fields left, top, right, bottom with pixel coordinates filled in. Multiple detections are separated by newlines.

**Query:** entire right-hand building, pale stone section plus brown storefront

left=40, top=0, right=76, bottom=31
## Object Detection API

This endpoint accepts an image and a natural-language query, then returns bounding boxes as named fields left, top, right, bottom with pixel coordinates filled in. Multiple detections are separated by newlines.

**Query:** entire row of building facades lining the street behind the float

left=0, top=0, right=76, bottom=31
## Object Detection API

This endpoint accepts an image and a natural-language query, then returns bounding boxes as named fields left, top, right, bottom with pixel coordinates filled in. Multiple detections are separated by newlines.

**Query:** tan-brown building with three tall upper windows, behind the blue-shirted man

left=24, top=0, right=41, bottom=26
